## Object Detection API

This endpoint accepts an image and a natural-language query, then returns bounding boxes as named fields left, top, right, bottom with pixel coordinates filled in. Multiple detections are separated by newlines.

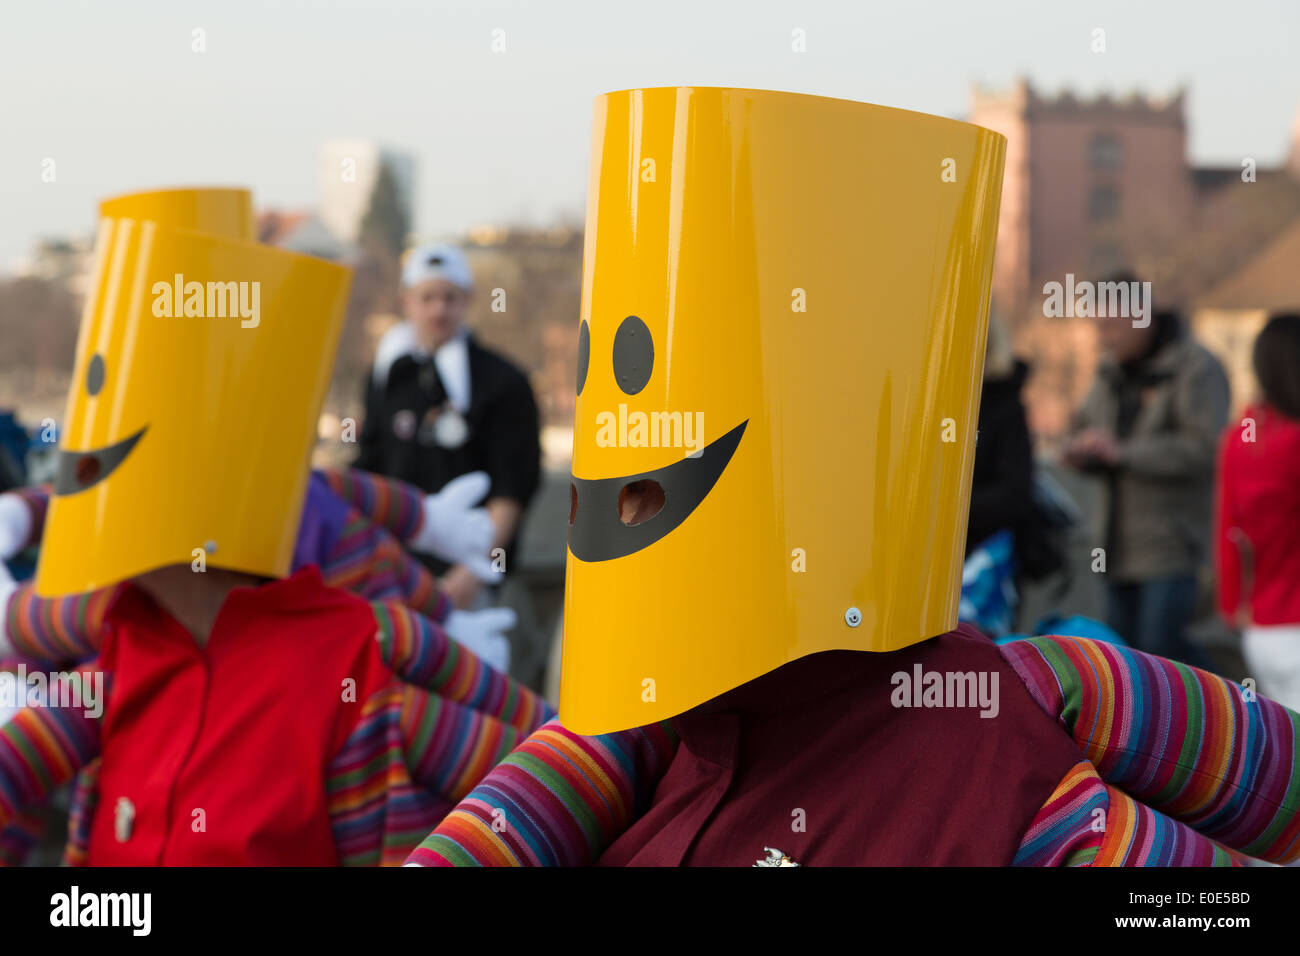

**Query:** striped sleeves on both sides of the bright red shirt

left=0, top=600, right=554, bottom=865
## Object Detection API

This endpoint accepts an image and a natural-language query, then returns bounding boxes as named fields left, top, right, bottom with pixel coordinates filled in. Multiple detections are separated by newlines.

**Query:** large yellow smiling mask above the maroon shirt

left=560, top=88, right=1005, bottom=734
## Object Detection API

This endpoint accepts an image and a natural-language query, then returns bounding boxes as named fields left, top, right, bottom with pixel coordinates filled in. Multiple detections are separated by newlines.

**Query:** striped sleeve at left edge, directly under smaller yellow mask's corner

left=0, top=581, right=124, bottom=665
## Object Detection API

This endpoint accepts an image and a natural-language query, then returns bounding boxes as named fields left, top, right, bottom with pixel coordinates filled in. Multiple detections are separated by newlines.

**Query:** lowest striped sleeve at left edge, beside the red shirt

left=0, top=667, right=107, bottom=829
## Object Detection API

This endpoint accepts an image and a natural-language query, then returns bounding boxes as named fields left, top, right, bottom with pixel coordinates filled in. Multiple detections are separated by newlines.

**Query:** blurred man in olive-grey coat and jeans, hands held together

left=1065, top=274, right=1229, bottom=670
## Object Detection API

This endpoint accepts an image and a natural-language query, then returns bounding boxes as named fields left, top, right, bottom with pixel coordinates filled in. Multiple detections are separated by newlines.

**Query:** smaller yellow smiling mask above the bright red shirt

left=36, top=190, right=351, bottom=596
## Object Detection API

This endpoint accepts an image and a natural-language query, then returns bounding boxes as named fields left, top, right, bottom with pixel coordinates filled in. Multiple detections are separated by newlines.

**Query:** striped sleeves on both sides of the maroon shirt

left=408, top=637, right=1300, bottom=866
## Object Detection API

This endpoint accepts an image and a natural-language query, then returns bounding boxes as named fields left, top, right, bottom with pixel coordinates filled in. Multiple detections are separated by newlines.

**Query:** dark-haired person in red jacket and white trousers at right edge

left=1214, top=315, right=1300, bottom=709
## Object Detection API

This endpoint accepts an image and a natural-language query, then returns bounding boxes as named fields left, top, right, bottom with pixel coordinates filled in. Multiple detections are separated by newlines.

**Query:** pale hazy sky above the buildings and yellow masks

left=0, top=0, right=1300, bottom=271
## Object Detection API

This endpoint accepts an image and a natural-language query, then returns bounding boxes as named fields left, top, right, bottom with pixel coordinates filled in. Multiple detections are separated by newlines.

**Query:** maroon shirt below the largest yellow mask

left=599, top=626, right=1083, bottom=866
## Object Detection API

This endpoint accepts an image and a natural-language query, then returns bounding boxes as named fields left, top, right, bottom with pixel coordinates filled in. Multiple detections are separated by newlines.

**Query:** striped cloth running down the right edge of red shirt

left=325, top=682, right=455, bottom=866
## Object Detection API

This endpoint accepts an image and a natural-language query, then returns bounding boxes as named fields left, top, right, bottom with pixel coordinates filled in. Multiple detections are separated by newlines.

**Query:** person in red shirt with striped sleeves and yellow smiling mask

left=0, top=189, right=547, bottom=866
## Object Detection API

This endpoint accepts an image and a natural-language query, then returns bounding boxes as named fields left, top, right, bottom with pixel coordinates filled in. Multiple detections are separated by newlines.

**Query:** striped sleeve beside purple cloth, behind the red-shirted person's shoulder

left=321, top=507, right=451, bottom=620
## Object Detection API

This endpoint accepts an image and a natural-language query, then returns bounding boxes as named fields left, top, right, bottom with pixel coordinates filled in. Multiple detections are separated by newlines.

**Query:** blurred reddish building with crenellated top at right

left=969, top=79, right=1300, bottom=446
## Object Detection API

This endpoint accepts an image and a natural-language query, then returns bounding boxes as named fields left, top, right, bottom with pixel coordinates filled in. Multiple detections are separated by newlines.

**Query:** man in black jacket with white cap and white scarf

left=354, top=246, right=541, bottom=607
